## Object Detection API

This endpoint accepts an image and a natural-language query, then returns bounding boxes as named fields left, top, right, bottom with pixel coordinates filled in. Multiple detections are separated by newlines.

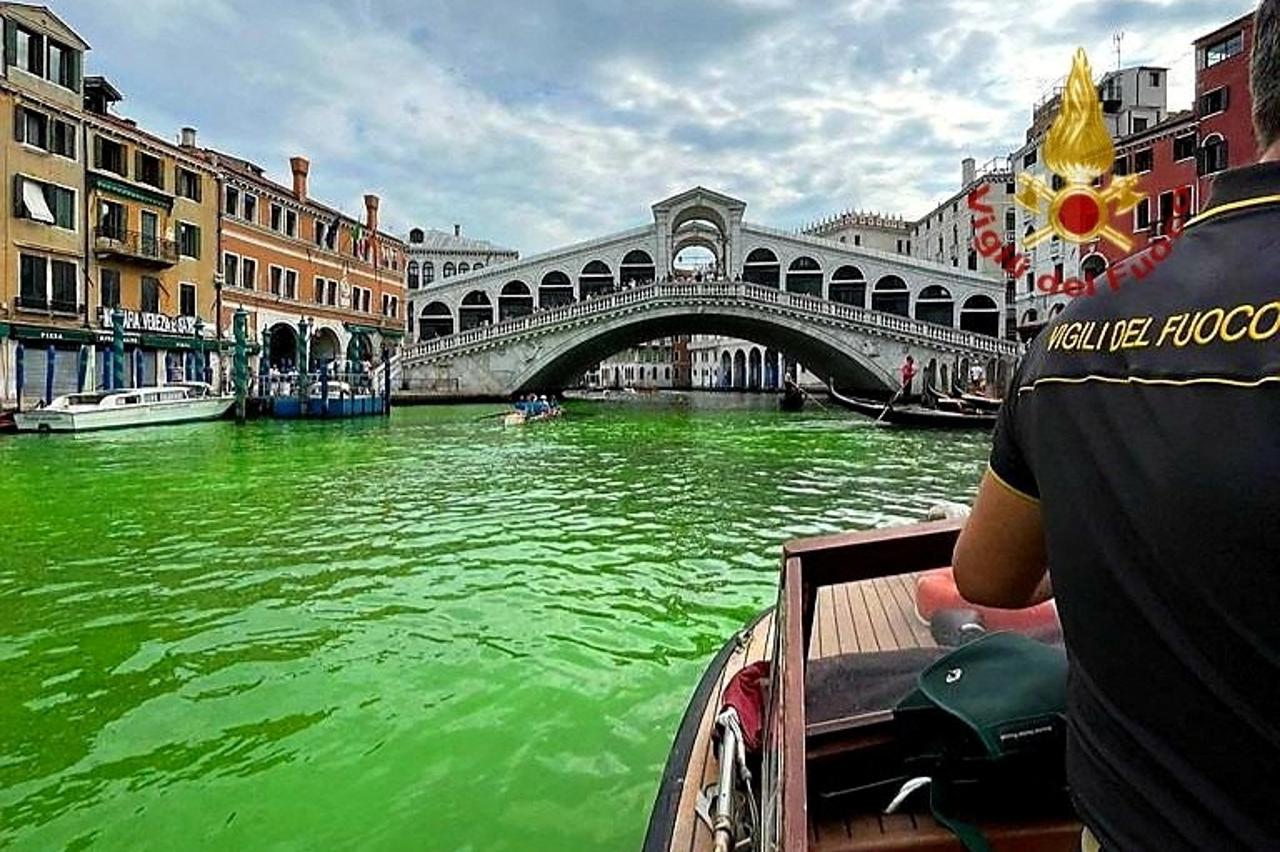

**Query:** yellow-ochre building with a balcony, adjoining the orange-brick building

left=84, top=77, right=220, bottom=386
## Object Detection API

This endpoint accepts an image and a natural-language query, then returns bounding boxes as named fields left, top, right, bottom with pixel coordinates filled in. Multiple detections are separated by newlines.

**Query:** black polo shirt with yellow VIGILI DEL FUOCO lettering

left=991, top=164, right=1280, bottom=852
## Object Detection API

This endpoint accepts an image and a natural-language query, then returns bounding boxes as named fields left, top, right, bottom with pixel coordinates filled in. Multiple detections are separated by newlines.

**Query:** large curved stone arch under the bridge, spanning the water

left=511, top=304, right=896, bottom=393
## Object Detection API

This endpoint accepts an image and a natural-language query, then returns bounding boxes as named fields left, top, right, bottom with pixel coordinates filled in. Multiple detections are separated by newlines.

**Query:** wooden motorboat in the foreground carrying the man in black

left=644, top=521, right=1082, bottom=852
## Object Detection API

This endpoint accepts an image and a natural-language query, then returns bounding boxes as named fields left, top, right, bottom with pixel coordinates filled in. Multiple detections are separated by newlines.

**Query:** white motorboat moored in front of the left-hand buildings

left=14, top=381, right=236, bottom=432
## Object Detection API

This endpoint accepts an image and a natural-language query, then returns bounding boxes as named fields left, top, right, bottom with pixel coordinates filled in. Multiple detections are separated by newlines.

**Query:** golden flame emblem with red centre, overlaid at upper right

left=1016, top=47, right=1146, bottom=252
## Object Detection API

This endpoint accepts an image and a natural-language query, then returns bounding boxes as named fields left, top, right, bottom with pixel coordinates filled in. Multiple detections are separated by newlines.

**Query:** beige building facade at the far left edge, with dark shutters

left=0, top=3, right=87, bottom=404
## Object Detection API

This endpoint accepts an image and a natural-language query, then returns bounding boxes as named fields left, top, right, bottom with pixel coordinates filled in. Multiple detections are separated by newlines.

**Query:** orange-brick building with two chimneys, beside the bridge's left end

left=205, top=150, right=406, bottom=372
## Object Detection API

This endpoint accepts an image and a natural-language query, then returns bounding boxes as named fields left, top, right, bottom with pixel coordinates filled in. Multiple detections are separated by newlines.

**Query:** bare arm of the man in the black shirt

left=951, top=471, right=1052, bottom=609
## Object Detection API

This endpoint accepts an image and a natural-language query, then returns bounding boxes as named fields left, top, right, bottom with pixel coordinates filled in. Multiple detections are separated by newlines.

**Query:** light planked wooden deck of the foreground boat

left=669, top=574, right=936, bottom=852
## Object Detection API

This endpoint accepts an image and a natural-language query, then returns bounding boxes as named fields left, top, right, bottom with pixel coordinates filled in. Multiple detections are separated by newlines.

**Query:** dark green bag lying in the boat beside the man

left=890, top=633, right=1071, bottom=852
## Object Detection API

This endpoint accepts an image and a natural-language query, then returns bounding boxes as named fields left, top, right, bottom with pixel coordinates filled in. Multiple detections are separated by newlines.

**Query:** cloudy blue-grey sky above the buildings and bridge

left=60, top=0, right=1253, bottom=255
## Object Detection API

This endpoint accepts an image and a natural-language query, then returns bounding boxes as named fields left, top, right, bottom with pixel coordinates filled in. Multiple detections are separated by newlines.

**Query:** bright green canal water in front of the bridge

left=0, top=398, right=987, bottom=852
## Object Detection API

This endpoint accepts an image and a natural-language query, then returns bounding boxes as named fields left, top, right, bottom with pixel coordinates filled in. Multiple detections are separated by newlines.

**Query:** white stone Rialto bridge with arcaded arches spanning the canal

left=393, top=187, right=1019, bottom=397
